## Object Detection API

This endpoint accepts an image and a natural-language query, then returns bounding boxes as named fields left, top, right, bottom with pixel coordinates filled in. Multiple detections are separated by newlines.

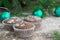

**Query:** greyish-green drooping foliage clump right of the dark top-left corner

left=11, top=0, right=22, bottom=15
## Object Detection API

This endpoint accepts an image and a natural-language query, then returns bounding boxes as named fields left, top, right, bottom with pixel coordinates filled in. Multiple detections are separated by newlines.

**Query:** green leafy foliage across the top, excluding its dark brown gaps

left=0, top=0, right=60, bottom=15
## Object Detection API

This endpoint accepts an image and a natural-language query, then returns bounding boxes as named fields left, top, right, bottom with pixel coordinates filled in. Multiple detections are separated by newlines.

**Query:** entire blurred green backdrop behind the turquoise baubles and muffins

left=0, top=0, right=60, bottom=16
